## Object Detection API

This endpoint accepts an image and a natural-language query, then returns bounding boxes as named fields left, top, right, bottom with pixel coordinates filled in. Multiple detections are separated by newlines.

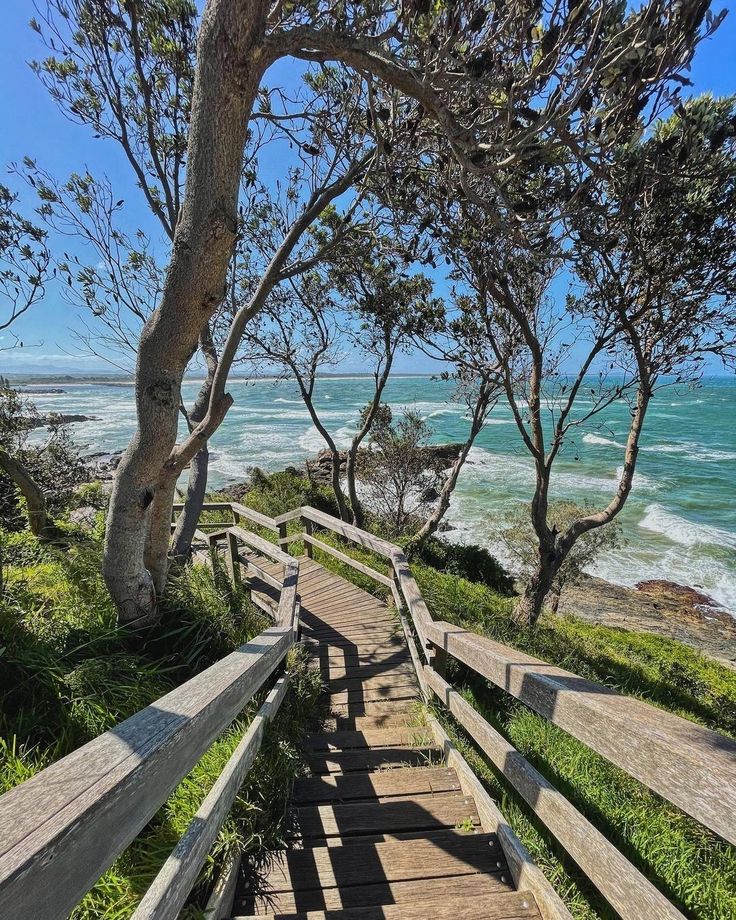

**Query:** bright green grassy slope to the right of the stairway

left=224, top=474, right=736, bottom=920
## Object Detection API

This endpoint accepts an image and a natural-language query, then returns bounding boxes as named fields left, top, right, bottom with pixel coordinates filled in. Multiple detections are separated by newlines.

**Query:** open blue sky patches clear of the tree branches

left=0, top=0, right=736, bottom=374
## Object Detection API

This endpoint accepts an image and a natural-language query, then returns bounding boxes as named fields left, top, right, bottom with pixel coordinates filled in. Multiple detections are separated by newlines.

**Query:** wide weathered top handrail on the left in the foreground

left=0, top=628, right=292, bottom=920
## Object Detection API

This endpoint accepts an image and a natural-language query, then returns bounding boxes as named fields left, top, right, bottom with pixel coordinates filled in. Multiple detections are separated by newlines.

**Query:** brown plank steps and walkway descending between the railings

left=234, top=557, right=540, bottom=920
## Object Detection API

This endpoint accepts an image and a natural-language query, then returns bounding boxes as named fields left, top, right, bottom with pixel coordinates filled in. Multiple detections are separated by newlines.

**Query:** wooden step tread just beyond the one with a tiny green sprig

left=293, top=767, right=460, bottom=805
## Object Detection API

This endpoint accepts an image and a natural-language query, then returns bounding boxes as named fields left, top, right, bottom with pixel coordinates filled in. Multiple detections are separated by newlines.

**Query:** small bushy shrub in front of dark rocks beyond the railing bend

left=358, top=404, right=442, bottom=537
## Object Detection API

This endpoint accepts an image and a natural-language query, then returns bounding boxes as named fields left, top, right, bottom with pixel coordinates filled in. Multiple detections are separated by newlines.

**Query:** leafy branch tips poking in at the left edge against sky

left=0, top=184, right=51, bottom=350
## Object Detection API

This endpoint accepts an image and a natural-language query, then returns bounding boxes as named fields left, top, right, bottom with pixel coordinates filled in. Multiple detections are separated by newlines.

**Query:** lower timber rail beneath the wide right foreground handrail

left=425, top=668, right=684, bottom=920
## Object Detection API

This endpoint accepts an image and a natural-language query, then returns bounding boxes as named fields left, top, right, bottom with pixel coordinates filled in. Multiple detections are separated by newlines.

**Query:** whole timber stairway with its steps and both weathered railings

left=0, top=502, right=736, bottom=920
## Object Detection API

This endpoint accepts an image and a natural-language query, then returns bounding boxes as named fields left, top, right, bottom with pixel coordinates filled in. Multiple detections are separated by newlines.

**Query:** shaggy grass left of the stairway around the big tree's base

left=0, top=524, right=321, bottom=920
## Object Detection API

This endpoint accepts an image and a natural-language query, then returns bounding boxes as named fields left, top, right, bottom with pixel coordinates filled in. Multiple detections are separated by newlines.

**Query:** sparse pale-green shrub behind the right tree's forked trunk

left=503, top=500, right=623, bottom=614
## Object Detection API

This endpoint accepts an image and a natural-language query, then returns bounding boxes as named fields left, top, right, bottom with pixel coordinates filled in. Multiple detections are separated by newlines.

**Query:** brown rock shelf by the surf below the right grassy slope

left=559, top=576, right=736, bottom=670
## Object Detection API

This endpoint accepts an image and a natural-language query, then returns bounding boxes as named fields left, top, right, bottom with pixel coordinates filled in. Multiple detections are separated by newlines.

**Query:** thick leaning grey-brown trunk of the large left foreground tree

left=103, top=0, right=269, bottom=625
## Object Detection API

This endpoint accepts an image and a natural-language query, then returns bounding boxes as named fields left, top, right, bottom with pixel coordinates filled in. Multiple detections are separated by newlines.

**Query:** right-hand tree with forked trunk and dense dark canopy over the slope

left=452, top=97, right=736, bottom=624
